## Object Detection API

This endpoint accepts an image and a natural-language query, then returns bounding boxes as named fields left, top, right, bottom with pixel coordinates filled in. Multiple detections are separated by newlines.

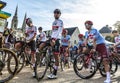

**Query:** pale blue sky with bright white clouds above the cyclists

left=2, top=0, right=120, bottom=34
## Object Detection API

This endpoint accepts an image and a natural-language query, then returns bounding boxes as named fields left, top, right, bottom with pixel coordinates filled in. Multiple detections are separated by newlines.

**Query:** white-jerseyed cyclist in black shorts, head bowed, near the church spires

left=25, top=18, right=37, bottom=77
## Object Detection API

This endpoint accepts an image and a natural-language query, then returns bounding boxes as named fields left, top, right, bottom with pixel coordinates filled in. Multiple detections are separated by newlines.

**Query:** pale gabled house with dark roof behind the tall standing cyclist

left=44, top=27, right=80, bottom=45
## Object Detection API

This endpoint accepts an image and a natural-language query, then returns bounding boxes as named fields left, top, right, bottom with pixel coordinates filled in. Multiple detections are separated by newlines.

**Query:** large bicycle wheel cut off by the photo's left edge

left=0, top=48, right=18, bottom=83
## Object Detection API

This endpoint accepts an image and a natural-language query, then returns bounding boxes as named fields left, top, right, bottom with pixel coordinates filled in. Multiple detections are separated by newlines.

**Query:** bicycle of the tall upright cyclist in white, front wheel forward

left=35, top=41, right=55, bottom=81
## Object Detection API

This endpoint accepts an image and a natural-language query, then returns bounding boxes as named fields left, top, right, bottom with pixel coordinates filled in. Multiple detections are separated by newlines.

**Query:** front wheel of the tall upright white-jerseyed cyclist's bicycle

left=35, top=53, right=48, bottom=81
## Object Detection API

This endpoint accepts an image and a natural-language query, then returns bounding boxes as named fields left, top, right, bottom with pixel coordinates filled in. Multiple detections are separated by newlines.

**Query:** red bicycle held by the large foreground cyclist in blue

left=73, top=52, right=118, bottom=79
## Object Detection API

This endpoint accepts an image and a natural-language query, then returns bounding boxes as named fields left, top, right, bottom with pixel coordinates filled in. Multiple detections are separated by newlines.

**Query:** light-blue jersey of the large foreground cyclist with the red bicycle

left=85, top=28, right=105, bottom=45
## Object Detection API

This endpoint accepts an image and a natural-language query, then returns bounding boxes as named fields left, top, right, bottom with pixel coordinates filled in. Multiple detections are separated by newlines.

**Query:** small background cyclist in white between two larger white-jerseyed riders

left=36, top=27, right=46, bottom=50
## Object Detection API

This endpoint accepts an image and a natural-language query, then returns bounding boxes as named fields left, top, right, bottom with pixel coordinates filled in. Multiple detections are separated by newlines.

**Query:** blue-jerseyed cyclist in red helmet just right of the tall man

left=61, top=29, right=70, bottom=67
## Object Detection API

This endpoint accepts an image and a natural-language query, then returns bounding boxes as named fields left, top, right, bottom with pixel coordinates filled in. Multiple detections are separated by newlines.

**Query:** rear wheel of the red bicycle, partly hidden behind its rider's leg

left=99, top=60, right=118, bottom=77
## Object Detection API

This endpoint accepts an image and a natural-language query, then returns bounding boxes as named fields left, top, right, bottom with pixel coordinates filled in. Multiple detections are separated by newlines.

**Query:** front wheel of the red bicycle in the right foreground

left=73, top=54, right=97, bottom=79
